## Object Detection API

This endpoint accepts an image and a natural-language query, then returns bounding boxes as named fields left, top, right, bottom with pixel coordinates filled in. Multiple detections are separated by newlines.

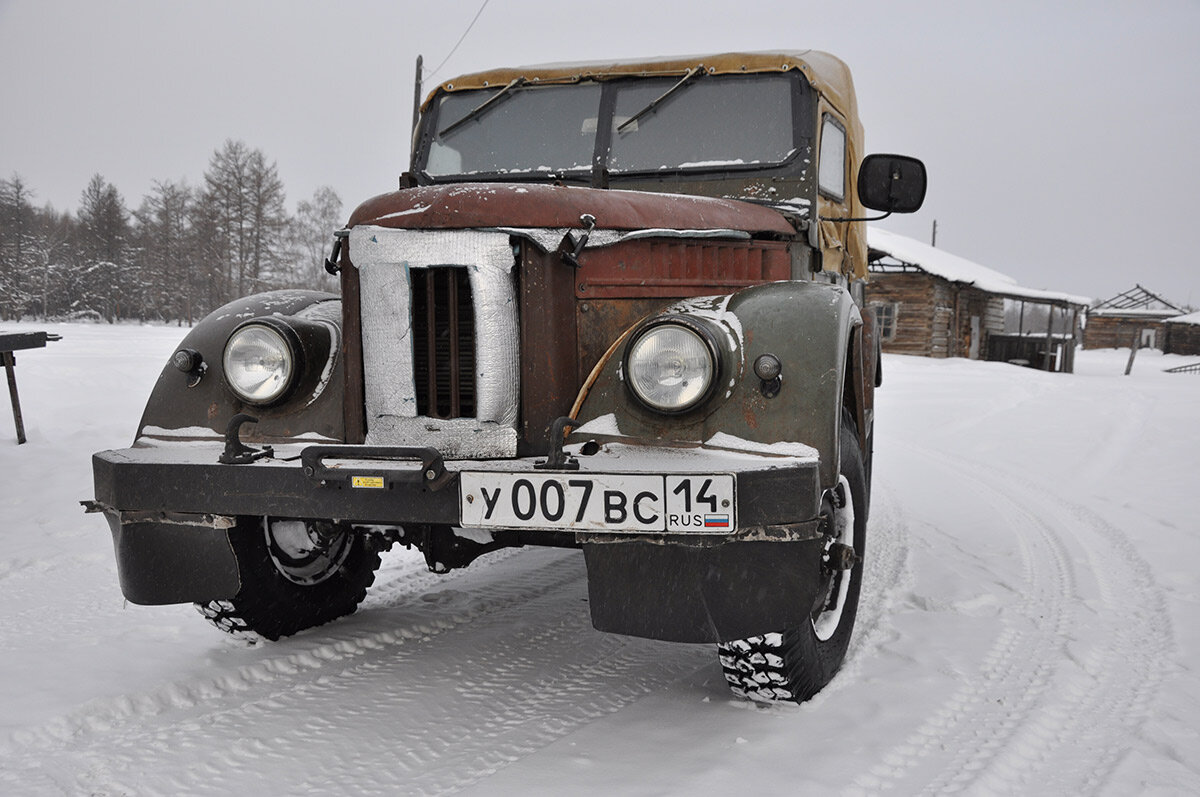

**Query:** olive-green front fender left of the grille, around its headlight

left=137, top=290, right=344, bottom=442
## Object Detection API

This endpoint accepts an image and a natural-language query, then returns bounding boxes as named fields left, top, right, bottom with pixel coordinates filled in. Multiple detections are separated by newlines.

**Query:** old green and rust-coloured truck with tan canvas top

left=90, top=52, right=925, bottom=701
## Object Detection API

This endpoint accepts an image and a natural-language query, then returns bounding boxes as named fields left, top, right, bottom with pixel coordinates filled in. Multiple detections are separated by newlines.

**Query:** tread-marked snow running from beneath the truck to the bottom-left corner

left=0, top=551, right=714, bottom=793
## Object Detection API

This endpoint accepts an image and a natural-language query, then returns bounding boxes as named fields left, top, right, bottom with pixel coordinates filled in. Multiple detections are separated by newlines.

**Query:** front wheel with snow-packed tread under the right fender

left=718, top=421, right=868, bottom=702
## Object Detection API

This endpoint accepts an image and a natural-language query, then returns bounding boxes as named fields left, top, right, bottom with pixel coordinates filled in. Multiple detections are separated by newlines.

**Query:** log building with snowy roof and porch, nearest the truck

left=866, top=227, right=1090, bottom=372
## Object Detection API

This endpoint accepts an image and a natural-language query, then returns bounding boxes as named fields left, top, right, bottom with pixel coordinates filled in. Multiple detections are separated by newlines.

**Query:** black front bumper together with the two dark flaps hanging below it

left=92, top=444, right=821, bottom=642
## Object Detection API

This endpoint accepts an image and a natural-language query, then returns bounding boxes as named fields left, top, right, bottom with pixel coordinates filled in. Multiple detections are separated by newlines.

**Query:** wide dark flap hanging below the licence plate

left=583, top=539, right=822, bottom=642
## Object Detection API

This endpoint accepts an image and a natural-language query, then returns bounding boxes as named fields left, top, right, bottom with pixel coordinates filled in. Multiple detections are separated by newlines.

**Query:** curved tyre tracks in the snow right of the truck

left=851, top=447, right=1172, bottom=795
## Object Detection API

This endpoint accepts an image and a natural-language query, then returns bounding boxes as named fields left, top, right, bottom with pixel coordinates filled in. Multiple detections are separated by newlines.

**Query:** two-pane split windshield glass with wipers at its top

left=418, top=74, right=796, bottom=178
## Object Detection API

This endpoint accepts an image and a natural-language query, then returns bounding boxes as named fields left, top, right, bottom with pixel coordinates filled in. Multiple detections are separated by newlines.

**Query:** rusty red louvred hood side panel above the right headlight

left=576, top=239, right=792, bottom=299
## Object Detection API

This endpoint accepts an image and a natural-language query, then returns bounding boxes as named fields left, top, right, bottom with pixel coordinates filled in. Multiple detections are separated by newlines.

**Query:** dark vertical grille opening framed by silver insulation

left=409, top=266, right=475, bottom=419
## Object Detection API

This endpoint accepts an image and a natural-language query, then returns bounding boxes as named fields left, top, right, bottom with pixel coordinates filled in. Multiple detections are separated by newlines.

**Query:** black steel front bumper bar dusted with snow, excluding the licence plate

left=92, top=443, right=821, bottom=532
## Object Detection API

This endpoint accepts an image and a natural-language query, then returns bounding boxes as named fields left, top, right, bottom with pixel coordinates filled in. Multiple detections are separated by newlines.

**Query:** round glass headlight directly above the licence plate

left=625, top=323, right=716, bottom=413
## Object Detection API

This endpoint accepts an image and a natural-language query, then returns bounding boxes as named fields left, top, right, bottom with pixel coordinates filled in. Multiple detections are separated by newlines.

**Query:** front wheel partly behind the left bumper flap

left=196, top=517, right=379, bottom=640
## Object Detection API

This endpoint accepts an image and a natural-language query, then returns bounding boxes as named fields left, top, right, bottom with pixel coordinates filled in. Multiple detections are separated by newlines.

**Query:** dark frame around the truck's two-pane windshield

left=412, top=70, right=817, bottom=187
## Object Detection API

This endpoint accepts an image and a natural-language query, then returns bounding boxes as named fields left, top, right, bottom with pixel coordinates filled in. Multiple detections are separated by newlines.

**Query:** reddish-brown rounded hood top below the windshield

left=348, top=182, right=796, bottom=235
